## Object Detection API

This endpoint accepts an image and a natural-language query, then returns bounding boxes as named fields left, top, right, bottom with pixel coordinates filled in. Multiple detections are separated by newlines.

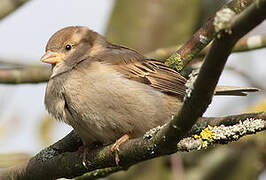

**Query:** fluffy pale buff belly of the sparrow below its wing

left=47, top=62, right=181, bottom=144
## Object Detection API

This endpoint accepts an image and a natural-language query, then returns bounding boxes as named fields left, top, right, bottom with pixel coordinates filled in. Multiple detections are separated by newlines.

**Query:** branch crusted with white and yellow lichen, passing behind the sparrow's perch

left=75, top=113, right=266, bottom=180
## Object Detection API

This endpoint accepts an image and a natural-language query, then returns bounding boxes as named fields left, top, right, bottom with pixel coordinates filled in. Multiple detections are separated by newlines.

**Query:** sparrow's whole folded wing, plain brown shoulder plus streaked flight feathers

left=95, top=46, right=186, bottom=98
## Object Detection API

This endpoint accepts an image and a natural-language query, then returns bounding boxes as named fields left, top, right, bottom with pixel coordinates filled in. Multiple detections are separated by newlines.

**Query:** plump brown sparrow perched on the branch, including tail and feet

left=41, top=26, right=257, bottom=166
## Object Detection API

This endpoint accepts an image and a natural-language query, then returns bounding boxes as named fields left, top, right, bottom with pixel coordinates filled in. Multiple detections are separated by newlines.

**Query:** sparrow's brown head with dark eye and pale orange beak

left=41, top=26, right=107, bottom=76
